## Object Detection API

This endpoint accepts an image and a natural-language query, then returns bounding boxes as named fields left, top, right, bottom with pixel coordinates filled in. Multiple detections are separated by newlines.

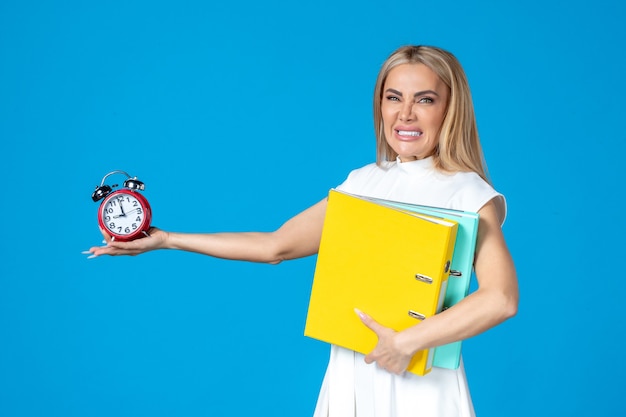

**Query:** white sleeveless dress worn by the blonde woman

left=314, top=158, right=506, bottom=417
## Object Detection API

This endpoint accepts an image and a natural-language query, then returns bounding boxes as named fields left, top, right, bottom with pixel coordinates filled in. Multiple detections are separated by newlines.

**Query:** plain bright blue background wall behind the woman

left=0, top=0, right=626, bottom=417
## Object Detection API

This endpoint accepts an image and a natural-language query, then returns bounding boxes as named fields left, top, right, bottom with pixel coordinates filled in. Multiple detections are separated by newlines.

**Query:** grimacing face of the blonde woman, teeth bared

left=381, top=64, right=449, bottom=162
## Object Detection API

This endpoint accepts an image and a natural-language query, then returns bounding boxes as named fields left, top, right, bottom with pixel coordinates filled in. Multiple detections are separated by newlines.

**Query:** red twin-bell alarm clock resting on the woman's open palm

left=91, top=171, right=152, bottom=242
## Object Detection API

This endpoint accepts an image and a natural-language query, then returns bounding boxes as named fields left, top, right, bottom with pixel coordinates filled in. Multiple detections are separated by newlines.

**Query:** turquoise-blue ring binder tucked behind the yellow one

left=356, top=197, right=479, bottom=369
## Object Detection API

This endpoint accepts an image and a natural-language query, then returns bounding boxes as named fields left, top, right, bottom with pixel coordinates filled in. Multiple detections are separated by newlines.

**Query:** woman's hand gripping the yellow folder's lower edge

left=355, top=310, right=413, bottom=375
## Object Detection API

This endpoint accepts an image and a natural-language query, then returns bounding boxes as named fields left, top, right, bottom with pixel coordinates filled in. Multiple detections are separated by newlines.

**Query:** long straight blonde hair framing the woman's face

left=374, top=45, right=489, bottom=182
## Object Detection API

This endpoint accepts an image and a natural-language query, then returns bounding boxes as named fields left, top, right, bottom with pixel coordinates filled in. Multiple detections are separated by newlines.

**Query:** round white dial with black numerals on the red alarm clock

left=100, top=193, right=149, bottom=237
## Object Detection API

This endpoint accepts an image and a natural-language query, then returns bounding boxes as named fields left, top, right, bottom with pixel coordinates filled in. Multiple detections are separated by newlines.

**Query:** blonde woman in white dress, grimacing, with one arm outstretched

left=90, top=46, right=518, bottom=417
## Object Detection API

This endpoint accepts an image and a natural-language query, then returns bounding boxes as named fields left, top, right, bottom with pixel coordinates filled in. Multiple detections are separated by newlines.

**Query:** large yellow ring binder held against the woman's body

left=304, top=189, right=458, bottom=375
